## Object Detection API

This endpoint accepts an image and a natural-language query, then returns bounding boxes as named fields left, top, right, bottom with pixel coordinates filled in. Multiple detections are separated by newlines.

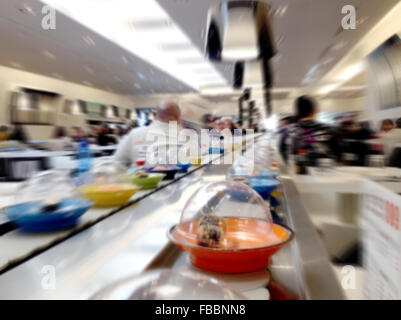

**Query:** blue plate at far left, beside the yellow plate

left=4, top=198, right=93, bottom=232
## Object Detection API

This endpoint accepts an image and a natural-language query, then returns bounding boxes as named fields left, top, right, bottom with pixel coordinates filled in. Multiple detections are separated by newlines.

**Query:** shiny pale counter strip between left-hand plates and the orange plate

left=0, top=156, right=222, bottom=299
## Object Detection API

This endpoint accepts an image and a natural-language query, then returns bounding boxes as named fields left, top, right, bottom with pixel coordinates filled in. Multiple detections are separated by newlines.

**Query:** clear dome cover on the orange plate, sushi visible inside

left=174, top=181, right=275, bottom=249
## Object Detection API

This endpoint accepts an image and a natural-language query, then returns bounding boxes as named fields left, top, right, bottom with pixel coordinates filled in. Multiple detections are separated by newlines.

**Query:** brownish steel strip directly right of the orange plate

left=276, top=178, right=345, bottom=300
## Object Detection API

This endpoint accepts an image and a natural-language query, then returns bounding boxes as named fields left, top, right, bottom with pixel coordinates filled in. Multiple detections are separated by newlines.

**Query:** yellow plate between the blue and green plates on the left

left=79, top=186, right=139, bottom=207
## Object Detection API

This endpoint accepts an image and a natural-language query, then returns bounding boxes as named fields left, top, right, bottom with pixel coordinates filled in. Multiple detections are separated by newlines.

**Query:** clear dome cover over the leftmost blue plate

left=14, top=170, right=75, bottom=204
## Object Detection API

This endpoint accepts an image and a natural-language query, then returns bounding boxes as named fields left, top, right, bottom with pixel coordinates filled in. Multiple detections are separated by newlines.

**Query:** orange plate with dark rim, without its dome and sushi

left=168, top=218, right=294, bottom=273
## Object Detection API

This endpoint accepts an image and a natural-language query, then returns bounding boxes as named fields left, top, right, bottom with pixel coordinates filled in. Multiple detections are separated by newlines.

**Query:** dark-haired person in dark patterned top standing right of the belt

left=290, top=96, right=332, bottom=166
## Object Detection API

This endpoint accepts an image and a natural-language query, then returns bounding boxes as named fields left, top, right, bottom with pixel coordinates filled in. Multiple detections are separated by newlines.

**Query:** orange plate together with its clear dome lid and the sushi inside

left=168, top=181, right=294, bottom=273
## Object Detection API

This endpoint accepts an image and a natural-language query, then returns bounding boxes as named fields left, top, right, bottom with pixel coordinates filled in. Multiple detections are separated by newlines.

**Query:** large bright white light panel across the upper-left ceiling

left=42, top=0, right=227, bottom=91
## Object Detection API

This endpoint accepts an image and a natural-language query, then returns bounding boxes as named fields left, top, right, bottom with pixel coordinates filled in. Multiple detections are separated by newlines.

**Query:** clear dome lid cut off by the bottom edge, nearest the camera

left=92, top=270, right=246, bottom=300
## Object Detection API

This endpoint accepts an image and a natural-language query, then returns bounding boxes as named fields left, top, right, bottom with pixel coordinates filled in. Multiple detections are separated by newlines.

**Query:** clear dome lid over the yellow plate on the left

left=84, top=160, right=127, bottom=185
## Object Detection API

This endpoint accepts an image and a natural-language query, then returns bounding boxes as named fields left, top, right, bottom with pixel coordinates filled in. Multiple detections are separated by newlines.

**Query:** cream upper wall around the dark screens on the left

left=0, top=66, right=135, bottom=140
